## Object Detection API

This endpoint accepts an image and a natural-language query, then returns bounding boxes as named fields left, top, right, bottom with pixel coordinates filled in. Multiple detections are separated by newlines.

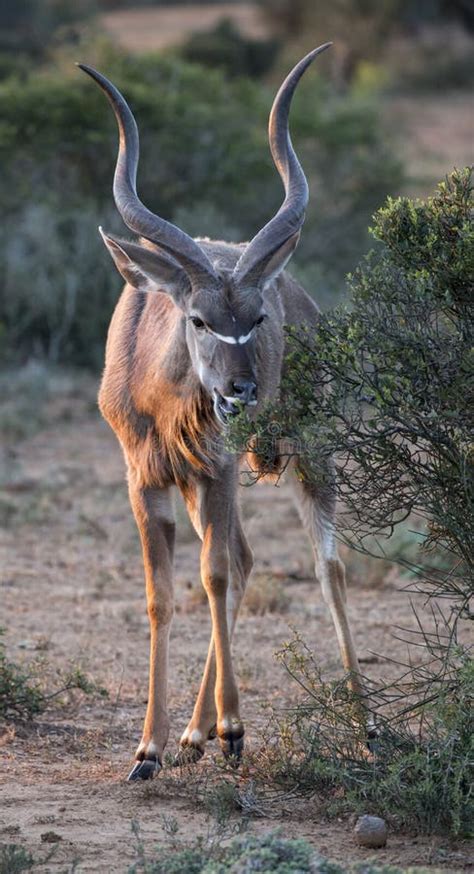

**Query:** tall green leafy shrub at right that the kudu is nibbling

left=236, top=170, right=474, bottom=615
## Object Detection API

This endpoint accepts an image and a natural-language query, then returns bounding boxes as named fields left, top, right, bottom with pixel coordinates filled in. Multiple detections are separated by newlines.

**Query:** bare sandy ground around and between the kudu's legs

left=0, top=384, right=469, bottom=872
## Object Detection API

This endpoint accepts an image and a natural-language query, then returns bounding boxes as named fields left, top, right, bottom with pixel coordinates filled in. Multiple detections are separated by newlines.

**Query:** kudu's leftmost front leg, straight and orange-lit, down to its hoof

left=128, top=474, right=175, bottom=781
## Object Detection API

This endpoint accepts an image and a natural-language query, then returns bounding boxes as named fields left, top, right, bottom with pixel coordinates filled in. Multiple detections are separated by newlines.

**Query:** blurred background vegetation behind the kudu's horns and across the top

left=0, top=0, right=474, bottom=370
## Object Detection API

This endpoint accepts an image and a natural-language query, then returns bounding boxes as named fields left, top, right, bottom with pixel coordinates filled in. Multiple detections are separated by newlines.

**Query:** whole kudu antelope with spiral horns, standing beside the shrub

left=80, top=43, right=360, bottom=780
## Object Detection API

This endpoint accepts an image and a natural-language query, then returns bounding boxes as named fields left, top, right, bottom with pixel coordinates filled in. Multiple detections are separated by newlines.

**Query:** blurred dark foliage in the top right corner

left=260, top=0, right=474, bottom=92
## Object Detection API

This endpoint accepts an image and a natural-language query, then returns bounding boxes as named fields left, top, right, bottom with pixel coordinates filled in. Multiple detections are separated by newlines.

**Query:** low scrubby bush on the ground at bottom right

left=257, top=636, right=474, bottom=836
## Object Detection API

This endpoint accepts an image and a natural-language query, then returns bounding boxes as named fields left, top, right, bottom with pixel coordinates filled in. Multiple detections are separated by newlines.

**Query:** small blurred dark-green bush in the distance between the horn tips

left=179, top=19, right=278, bottom=77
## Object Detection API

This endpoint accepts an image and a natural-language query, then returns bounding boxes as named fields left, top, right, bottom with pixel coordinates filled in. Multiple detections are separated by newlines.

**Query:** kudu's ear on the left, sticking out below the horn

left=99, top=228, right=191, bottom=307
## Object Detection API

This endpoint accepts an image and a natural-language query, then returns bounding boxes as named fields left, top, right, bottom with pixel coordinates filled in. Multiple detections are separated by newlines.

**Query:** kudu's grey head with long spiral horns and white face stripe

left=79, top=43, right=331, bottom=424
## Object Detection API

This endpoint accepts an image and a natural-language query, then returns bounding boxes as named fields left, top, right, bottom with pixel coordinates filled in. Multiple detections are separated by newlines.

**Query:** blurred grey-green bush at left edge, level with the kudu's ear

left=0, top=202, right=120, bottom=368
